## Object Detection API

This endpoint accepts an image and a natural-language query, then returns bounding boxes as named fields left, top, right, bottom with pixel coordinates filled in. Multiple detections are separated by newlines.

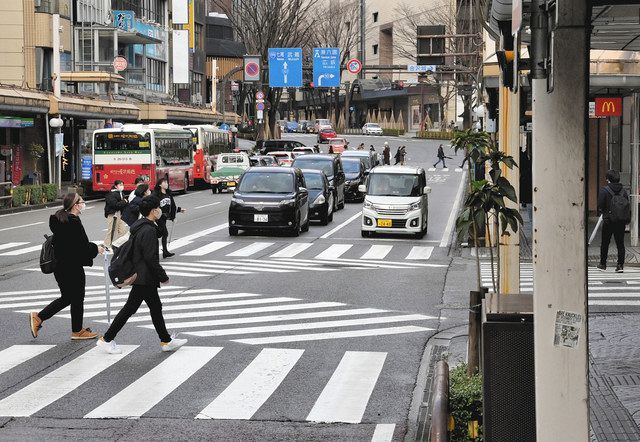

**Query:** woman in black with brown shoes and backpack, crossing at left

left=29, top=193, right=104, bottom=341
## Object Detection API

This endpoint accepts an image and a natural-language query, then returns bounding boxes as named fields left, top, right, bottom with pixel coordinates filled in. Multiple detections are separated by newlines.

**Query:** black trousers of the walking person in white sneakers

left=104, top=285, right=171, bottom=342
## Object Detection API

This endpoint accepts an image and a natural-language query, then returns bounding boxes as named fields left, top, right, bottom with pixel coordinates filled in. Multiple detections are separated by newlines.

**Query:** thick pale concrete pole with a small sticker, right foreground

left=532, top=0, right=590, bottom=442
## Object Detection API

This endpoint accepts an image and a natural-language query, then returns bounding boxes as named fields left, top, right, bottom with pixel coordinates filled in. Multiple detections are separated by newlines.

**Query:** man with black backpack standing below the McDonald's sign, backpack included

left=598, top=170, right=631, bottom=273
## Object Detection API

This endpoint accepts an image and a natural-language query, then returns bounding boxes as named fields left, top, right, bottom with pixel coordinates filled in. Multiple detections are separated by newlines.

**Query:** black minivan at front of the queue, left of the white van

left=229, top=167, right=309, bottom=236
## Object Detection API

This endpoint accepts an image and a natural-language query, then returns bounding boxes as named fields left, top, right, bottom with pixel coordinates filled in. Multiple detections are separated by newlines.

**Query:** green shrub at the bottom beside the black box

left=449, top=364, right=483, bottom=442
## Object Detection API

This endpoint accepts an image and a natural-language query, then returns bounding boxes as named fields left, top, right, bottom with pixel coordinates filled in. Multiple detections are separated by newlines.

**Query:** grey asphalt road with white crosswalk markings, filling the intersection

left=0, top=135, right=463, bottom=440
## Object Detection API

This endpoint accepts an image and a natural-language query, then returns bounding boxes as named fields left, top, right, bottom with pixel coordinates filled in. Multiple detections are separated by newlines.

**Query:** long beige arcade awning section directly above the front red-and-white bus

left=49, top=95, right=140, bottom=121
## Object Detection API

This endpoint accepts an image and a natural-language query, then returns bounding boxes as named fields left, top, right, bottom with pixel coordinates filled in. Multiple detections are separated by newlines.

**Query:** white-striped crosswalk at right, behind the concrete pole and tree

left=480, top=262, right=640, bottom=307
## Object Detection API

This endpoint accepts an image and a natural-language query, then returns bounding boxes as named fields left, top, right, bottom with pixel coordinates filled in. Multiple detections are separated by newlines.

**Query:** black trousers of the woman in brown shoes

left=38, top=266, right=86, bottom=333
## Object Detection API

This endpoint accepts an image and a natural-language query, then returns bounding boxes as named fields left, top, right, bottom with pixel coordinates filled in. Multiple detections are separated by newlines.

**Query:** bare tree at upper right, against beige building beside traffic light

left=394, top=0, right=482, bottom=128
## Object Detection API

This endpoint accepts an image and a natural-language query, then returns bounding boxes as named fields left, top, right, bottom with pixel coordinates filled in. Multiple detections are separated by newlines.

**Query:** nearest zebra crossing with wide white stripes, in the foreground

left=0, top=345, right=394, bottom=423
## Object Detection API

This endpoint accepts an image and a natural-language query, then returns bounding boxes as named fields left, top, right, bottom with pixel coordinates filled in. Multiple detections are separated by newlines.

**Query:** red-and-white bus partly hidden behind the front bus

left=184, top=124, right=232, bottom=186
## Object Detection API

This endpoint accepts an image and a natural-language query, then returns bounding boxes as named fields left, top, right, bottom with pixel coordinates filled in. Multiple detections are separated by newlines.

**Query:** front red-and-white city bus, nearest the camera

left=92, top=124, right=194, bottom=192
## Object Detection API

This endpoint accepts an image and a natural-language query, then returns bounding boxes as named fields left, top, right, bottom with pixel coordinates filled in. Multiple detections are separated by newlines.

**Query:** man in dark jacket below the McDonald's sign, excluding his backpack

left=598, top=170, right=629, bottom=273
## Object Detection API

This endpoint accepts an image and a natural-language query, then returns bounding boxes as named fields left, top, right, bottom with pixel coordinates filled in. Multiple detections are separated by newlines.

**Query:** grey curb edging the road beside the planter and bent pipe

left=404, top=324, right=468, bottom=442
